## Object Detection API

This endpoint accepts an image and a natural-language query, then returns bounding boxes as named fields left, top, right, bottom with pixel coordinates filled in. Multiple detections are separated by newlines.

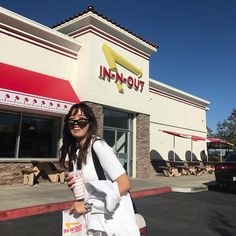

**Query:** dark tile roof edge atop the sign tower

left=51, top=6, right=159, bottom=48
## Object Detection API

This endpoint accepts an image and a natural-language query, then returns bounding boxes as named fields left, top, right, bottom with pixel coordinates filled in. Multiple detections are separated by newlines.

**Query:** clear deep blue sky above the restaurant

left=0, top=0, right=236, bottom=132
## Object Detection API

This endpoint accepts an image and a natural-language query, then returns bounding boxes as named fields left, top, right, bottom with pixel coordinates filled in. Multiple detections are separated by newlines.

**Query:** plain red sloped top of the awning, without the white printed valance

left=0, top=63, right=79, bottom=103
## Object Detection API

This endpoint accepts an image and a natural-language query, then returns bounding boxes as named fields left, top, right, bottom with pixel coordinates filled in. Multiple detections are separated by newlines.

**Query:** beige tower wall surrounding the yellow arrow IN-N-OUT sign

left=73, top=33, right=149, bottom=113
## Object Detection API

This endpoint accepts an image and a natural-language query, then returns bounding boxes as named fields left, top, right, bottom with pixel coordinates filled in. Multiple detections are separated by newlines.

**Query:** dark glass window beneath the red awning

left=0, top=111, right=60, bottom=158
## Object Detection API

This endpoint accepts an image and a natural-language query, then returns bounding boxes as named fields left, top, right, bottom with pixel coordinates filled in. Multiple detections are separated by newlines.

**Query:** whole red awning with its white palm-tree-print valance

left=0, top=63, right=79, bottom=113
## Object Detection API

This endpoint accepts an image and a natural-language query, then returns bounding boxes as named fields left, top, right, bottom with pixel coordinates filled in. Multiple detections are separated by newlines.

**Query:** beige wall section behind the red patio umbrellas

left=147, top=82, right=209, bottom=160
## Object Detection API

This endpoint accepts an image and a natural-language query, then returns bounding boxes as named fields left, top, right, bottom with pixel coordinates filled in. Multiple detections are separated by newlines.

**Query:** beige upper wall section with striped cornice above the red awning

left=0, top=8, right=81, bottom=85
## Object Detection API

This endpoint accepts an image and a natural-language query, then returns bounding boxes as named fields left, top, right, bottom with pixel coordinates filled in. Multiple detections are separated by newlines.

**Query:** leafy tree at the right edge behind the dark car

left=216, top=108, right=236, bottom=148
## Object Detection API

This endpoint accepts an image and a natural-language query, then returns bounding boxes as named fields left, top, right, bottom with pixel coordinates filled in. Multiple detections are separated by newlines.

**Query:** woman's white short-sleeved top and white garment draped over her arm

left=77, top=140, right=140, bottom=236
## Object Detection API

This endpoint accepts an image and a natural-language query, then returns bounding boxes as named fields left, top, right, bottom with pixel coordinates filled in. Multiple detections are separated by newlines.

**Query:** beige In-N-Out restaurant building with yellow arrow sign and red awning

left=0, top=7, right=209, bottom=185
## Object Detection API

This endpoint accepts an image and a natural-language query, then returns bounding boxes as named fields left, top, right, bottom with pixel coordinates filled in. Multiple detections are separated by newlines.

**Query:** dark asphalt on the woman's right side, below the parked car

left=136, top=191, right=236, bottom=236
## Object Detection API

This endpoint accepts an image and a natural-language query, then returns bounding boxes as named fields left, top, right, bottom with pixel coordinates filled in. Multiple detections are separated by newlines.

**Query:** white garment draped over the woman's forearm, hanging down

left=85, top=180, right=140, bottom=236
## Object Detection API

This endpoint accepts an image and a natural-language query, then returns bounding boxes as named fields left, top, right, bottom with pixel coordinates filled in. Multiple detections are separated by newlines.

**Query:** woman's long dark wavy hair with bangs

left=60, top=102, right=97, bottom=171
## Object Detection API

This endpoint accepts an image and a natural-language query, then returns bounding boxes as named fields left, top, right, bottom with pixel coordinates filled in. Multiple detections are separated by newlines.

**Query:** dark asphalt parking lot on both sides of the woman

left=0, top=188, right=236, bottom=236
